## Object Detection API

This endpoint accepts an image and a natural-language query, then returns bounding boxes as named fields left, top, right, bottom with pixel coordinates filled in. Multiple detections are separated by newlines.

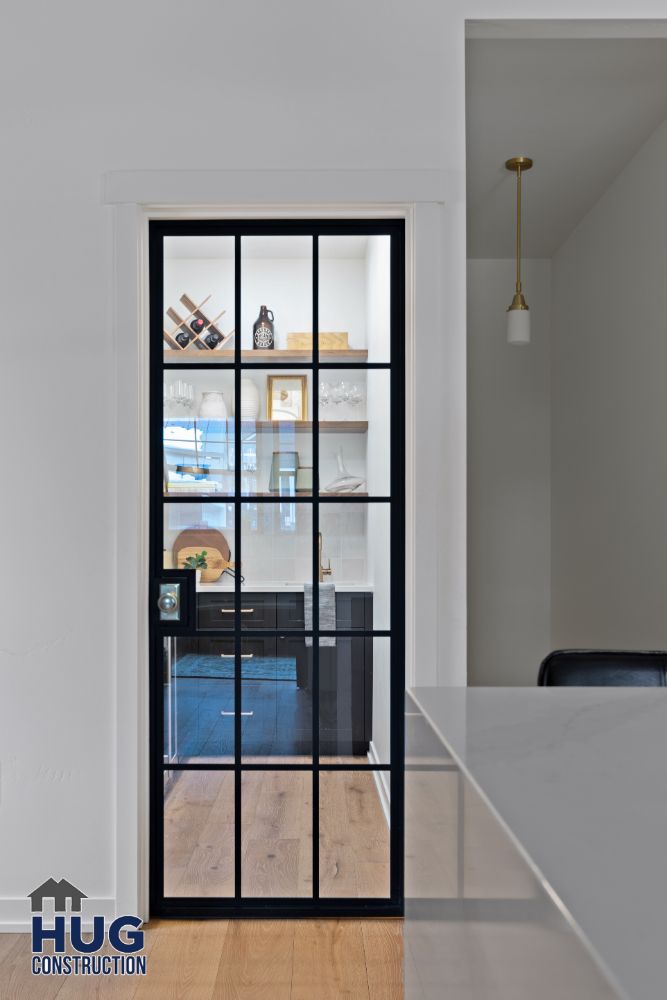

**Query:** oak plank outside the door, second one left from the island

left=290, top=920, right=370, bottom=1000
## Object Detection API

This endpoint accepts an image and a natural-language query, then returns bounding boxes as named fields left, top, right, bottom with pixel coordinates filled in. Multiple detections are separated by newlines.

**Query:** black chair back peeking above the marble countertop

left=537, top=649, right=667, bottom=687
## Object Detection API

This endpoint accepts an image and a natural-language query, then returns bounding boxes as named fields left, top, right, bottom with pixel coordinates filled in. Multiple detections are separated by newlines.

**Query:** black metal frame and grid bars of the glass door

left=148, top=219, right=405, bottom=918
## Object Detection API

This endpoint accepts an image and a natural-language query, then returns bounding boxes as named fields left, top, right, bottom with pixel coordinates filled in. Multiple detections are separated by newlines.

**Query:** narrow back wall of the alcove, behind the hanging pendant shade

left=468, top=260, right=551, bottom=686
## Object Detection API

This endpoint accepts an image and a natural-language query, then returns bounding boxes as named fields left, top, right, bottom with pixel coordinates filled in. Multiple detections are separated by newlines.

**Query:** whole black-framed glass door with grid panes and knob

left=149, top=219, right=405, bottom=917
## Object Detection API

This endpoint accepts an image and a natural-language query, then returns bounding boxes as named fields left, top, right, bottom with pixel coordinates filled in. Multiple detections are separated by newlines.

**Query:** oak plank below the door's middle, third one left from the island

left=211, top=920, right=294, bottom=1000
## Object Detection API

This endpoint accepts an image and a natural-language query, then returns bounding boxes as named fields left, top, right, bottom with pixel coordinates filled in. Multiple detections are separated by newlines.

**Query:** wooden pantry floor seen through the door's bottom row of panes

left=164, top=758, right=389, bottom=898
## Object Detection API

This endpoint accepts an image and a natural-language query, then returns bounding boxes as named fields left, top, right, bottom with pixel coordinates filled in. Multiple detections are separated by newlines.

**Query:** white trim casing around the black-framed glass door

left=109, top=171, right=456, bottom=918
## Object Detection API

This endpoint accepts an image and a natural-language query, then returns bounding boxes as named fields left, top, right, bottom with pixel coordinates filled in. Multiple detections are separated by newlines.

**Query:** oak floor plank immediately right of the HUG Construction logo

left=133, top=920, right=229, bottom=1000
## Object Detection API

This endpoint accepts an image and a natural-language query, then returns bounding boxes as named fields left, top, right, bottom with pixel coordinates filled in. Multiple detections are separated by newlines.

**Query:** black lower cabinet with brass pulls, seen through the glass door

left=190, top=591, right=373, bottom=757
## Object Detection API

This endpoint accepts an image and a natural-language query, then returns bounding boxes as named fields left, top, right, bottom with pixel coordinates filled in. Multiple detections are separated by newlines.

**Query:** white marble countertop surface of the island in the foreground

left=410, top=688, right=667, bottom=1000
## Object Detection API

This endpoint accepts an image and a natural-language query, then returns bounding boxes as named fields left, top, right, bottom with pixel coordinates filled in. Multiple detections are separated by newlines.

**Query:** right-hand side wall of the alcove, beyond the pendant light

left=552, top=109, right=667, bottom=649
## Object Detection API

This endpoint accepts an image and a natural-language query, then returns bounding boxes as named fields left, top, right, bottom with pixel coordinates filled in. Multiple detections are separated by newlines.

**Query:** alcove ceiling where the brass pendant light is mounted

left=466, top=38, right=667, bottom=258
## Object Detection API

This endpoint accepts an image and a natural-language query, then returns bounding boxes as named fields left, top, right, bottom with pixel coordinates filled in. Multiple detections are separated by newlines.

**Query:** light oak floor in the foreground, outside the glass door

left=0, top=920, right=403, bottom=1000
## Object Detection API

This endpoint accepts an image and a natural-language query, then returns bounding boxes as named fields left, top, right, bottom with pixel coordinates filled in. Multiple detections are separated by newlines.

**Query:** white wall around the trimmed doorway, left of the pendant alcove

left=0, top=0, right=664, bottom=927
